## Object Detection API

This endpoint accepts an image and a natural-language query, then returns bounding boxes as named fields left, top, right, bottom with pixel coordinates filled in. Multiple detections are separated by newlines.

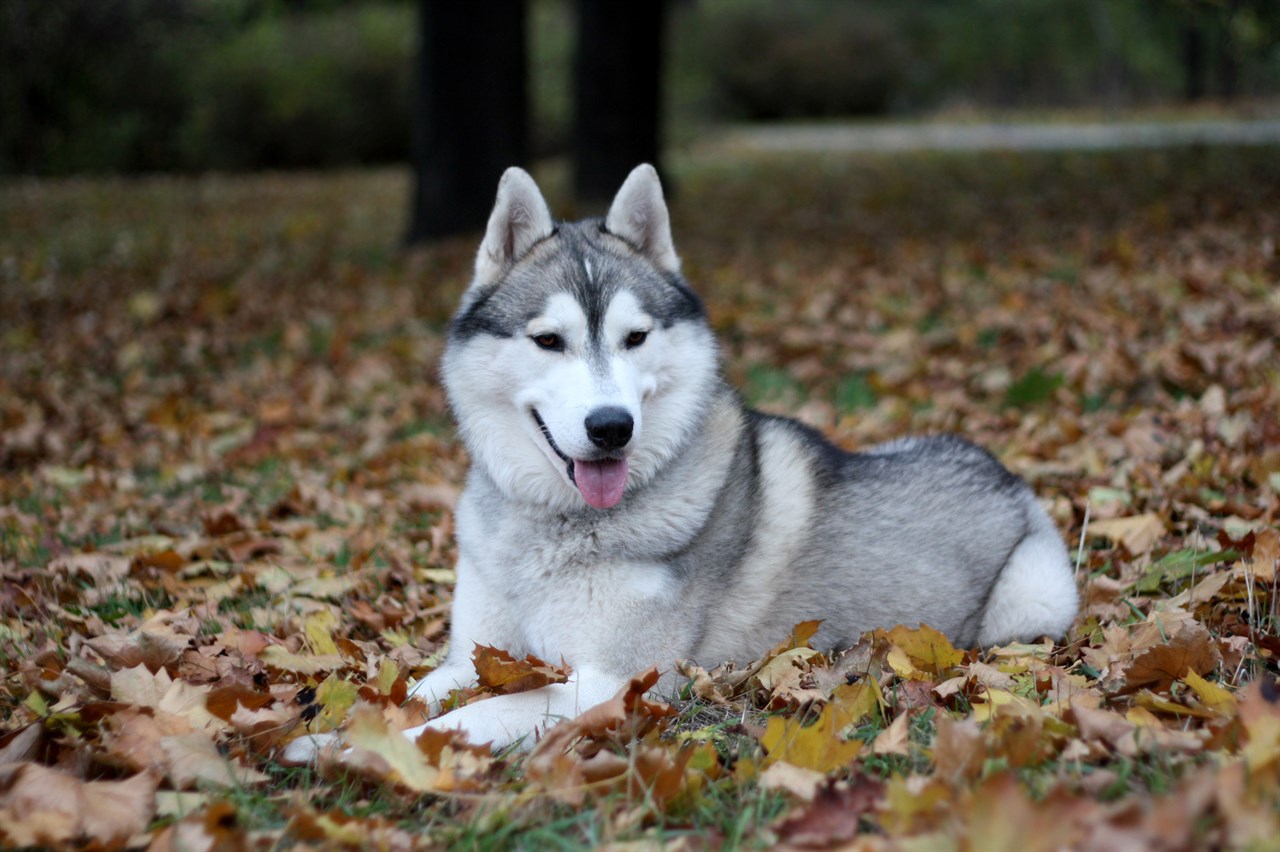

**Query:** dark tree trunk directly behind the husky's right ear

left=572, top=0, right=669, bottom=203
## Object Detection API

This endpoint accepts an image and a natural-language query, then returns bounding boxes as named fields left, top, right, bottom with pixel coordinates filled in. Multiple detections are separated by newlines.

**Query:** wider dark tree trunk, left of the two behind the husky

left=406, top=0, right=529, bottom=243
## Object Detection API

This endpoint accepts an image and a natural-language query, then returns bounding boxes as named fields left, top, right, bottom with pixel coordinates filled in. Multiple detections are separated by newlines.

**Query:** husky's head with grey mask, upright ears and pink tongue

left=444, top=165, right=717, bottom=510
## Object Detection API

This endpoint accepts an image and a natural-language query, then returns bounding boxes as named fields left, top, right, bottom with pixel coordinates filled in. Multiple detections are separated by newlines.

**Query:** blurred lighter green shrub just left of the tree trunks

left=182, top=4, right=416, bottom=169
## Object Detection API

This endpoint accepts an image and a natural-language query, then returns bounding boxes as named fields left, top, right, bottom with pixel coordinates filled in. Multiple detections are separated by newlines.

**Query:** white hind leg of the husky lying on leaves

left=978, top=507, right=1079, bottom=646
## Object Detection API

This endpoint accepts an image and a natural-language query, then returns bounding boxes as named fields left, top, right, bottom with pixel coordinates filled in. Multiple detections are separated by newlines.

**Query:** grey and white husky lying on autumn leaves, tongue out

left=394, top=165, right=1076, bottom=747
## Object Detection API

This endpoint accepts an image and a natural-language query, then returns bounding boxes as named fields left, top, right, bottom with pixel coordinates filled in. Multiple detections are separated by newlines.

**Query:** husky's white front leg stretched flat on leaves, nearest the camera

left=404, top=668, right=627, bottom=750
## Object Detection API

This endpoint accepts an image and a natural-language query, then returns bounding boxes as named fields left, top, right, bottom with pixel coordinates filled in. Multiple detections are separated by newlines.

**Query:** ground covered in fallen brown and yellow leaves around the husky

left=0, top=148, right=1280, bottom=849
